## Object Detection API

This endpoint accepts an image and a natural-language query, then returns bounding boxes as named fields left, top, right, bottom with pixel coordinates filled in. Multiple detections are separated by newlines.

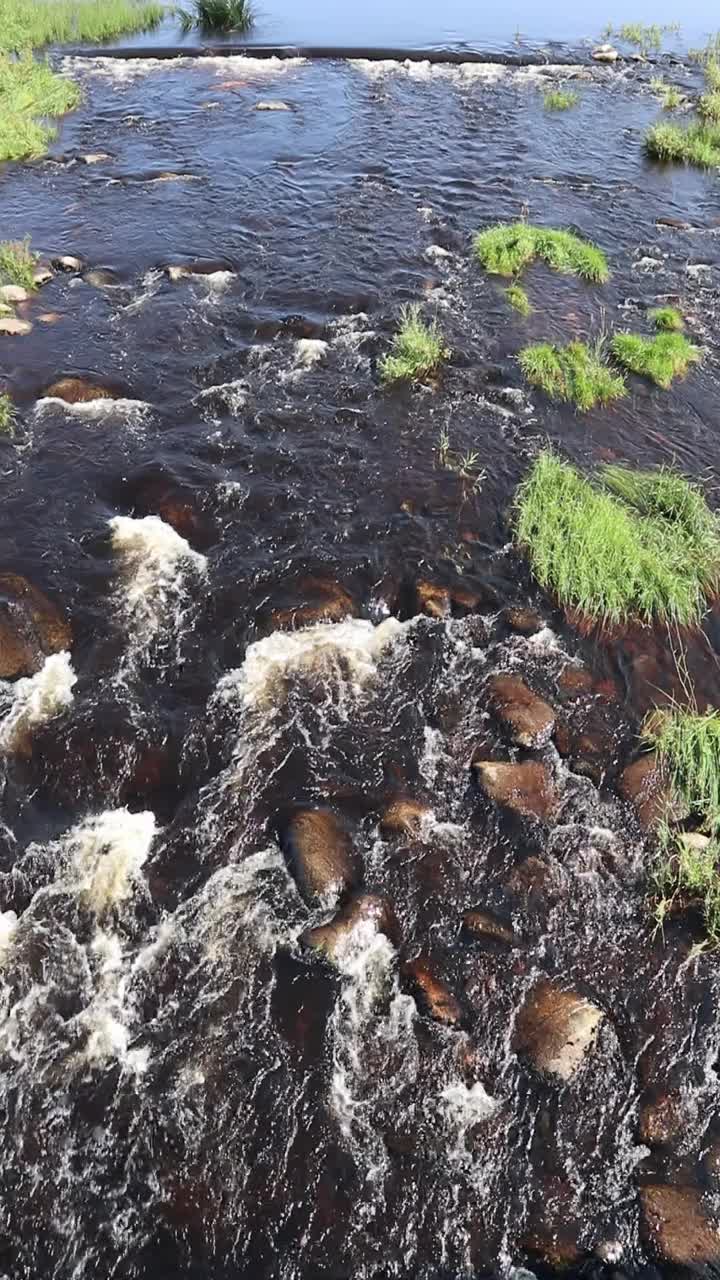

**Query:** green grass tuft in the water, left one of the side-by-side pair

left=518, top=342, right=625, bottom=412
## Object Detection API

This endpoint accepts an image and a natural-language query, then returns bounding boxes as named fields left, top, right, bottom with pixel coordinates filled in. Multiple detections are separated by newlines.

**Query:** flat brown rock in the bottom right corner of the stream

left=641, top=1183, right=720, bottom=1266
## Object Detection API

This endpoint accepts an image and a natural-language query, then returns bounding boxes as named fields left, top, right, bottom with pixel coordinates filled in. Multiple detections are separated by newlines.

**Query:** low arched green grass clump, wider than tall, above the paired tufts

left=474, top=223, right=610, bottom=284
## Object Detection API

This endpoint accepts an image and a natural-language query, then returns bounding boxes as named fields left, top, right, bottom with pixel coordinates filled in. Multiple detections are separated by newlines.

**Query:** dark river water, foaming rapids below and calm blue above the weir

left=0, top=17, right=720, bottom=1280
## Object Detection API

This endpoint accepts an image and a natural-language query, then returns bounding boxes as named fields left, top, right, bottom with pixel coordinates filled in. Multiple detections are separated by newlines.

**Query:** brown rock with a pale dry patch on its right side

left=512, top=979, right=605, bottom=1080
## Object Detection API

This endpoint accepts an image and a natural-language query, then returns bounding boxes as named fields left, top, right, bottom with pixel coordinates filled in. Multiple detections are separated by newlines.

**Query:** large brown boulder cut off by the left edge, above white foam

left=0, top=573, right=73, bottom=680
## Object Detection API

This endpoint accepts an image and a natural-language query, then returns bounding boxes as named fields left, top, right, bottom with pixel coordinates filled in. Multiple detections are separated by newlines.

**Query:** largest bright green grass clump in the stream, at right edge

left=515, top=449, right=720, bottom=626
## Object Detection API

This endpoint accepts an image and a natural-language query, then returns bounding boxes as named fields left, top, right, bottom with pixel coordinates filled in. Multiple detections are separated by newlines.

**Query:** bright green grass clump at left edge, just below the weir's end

left=0, top=52, right=82, bottom=161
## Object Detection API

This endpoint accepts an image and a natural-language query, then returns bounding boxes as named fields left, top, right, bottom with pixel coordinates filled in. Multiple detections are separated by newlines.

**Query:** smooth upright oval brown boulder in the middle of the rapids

left=282, top=809, right=363, bottom=904
